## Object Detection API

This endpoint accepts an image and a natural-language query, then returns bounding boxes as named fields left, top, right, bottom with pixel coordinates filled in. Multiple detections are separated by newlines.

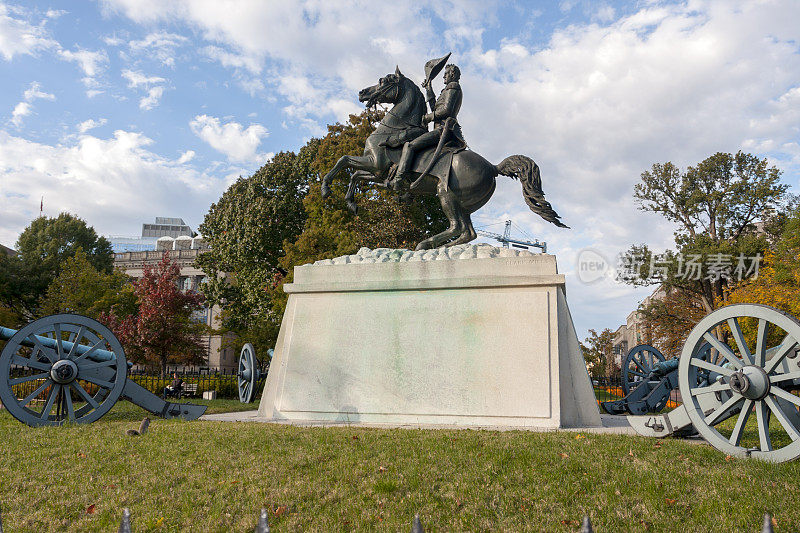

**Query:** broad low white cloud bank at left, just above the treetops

left=0, top=130, right=225, bottom=244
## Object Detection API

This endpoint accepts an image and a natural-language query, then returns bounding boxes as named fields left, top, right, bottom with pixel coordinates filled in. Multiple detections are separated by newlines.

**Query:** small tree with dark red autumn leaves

left=100, top=252, right=205, bottom=377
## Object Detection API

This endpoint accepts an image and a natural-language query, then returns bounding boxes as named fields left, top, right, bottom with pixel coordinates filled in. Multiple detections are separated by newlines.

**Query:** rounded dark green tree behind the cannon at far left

left=0, top=213, right=113, bottom=319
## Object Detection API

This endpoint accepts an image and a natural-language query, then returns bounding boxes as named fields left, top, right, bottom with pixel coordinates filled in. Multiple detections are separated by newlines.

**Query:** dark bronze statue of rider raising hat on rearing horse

left=322, top=54, right=568, bottom=250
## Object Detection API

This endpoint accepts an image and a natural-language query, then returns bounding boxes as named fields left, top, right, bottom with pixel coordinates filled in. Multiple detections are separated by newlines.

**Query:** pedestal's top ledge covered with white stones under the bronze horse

left=284, top=244, right=565, bottom=293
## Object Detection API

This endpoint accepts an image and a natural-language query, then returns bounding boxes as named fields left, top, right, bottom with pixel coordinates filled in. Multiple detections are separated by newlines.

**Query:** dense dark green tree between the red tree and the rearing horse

left=196, top=140, right=318, bottom=353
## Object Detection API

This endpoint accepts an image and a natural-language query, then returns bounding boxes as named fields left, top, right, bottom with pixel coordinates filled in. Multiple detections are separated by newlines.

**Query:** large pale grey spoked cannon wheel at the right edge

left=678, top=304, right=800, bottom=463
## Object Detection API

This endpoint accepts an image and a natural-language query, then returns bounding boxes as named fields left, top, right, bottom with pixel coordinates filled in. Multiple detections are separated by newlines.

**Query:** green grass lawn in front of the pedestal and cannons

left=0, top=400, right=800, bottom=533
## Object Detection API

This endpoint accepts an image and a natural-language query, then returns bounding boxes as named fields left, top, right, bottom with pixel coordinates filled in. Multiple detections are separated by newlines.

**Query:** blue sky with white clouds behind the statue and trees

left=0, top=0, right=800, bottom=338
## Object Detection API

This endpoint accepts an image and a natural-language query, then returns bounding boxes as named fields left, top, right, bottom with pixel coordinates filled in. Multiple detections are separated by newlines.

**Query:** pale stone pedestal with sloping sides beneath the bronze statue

left=258, top=245, right=600, bottom=428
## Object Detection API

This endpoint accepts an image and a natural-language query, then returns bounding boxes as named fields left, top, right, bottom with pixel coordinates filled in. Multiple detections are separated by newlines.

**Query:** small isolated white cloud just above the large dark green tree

left=189, top=115, right=269, bottom=162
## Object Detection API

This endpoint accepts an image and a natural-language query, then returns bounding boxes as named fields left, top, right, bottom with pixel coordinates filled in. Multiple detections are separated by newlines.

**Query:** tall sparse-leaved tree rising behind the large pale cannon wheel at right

left=619, top=152, right=788, bottom=343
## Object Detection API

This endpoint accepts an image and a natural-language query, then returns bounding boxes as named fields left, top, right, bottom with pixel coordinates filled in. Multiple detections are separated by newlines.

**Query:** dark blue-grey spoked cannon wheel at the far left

left=0, top=314, right=128, bottom=426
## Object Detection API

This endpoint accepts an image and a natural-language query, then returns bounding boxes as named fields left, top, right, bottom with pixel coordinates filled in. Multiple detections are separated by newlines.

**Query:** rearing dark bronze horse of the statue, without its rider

left=322, top=68, right=568, bottom=250
